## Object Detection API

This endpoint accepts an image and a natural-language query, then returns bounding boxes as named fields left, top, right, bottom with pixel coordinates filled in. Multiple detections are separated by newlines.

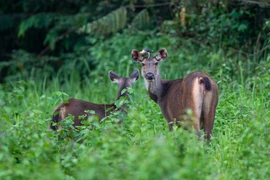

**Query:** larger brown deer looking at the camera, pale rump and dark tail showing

left=131, top=49, right=218, bottom=140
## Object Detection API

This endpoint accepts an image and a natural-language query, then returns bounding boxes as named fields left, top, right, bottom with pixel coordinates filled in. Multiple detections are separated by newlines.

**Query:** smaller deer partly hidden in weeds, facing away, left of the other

left=51, top=70, right=139, bottom=130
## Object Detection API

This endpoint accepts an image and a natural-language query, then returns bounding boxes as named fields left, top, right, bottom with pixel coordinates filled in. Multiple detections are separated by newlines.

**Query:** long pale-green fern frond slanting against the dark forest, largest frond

left=77, top=7, right=127, bottom=35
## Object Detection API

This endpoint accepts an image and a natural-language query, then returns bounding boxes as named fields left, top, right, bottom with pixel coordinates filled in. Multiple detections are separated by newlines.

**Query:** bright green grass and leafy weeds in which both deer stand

left=0, top=46, right=270, bottom=180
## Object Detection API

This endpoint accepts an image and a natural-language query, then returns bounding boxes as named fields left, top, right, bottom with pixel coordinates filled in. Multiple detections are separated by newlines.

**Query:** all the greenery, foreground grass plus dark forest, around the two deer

left=0, top=0, right=270, bottom=180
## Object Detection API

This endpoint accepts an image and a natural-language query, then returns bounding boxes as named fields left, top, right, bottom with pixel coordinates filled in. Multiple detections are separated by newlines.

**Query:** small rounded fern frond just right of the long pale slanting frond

left=131, top=9, right=150, bottom=29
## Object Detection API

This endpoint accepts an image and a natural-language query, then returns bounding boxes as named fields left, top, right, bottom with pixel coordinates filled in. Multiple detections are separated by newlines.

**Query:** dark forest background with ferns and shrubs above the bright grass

left=0, top=0, right=270, bottom=83
